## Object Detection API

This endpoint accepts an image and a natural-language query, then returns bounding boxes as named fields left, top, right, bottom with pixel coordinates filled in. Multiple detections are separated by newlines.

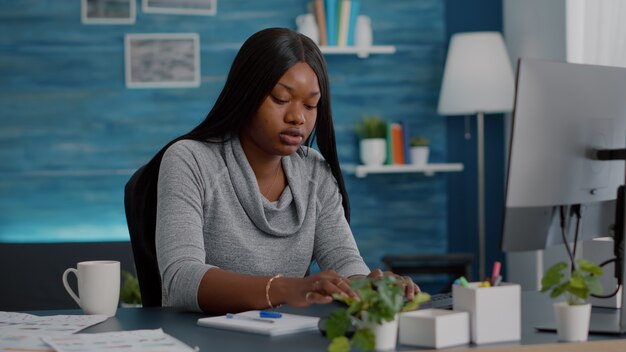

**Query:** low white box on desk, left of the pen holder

left=399, top=309, right=469, bottom=348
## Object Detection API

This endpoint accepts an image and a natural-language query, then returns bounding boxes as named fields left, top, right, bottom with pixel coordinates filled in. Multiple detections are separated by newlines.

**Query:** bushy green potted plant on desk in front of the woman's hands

left=326, top=276, right=430, bottom=352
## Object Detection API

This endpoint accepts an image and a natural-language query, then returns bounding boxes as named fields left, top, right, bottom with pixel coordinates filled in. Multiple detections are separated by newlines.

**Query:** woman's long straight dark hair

left=129, top=28, right=350, bottom=223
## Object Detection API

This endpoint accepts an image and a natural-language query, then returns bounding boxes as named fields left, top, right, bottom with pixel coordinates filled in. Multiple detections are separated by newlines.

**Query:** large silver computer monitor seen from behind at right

left=501, top=59, right=626, bottom=333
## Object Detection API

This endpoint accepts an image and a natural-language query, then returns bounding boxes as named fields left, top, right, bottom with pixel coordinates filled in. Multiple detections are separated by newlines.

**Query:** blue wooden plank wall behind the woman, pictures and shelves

left=0, top=0, right=464, bottom=276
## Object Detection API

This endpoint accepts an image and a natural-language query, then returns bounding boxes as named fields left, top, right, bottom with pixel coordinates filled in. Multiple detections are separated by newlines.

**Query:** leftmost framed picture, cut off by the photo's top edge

left=80, top=0, right=137, bottom=24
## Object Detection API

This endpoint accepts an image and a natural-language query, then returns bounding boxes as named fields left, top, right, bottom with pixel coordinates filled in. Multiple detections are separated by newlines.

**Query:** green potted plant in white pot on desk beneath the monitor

left=541, top=259, right=602, bottom=341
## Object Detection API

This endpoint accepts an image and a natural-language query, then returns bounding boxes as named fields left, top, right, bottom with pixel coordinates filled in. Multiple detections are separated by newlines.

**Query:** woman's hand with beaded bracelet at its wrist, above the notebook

left=274, top=270, right=358, bottom=307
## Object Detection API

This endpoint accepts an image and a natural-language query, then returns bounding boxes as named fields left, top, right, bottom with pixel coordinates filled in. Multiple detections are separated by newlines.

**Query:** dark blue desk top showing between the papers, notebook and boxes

left=29, top=292, right=625, bottom=352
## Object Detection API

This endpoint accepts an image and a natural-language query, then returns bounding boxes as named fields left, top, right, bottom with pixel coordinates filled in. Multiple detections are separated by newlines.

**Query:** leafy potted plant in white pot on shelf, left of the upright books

left=356, top=116, right=387, bottom=165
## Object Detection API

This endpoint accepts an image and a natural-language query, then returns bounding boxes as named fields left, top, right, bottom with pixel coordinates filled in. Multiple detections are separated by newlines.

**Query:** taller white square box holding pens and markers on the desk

left=452, top=282, right=522, bottom=344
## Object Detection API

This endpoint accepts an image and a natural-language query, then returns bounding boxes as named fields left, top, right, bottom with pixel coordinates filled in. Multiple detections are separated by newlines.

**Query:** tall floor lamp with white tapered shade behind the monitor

left=438, top=32, right=514, bottom=280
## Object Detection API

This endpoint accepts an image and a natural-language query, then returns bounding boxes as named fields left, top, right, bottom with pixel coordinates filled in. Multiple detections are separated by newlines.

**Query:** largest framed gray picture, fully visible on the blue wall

left=124, top=33, right=200, bottom=88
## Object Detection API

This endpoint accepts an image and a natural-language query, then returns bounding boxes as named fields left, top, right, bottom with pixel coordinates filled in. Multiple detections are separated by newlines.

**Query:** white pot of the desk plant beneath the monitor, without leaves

left=554, top=302, right=591, bottom=342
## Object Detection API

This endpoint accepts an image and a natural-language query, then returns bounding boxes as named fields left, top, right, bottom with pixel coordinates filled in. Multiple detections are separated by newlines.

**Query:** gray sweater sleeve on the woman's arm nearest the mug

left=156, top=143, right=212, bottom=311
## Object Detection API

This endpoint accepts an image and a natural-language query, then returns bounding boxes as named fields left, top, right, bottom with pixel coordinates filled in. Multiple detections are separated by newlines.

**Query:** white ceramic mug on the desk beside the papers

left=63, top=260, right=120, bottom=317
